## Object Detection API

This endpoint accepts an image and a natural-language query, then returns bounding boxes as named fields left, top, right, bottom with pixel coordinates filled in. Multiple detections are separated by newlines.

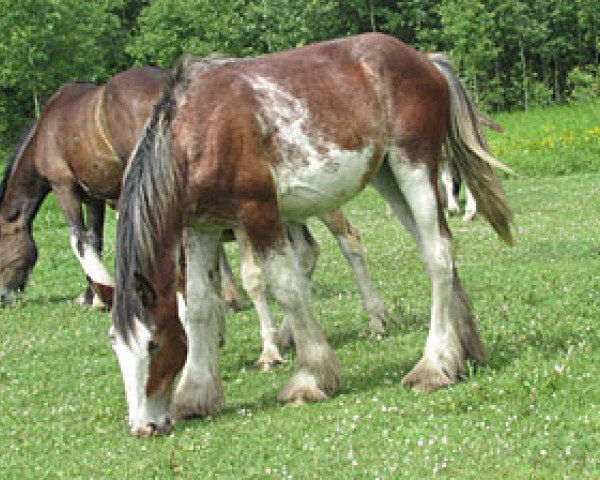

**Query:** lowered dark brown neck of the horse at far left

left=0, top=133, right=50, bottom=227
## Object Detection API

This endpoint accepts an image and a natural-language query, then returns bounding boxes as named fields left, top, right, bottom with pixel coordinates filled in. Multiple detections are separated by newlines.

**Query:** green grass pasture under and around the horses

left=0, top=105, right=600, bottom=479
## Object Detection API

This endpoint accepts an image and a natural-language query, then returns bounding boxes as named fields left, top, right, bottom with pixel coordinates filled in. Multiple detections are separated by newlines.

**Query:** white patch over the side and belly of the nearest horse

left=248, top=76, right=375, bottom=219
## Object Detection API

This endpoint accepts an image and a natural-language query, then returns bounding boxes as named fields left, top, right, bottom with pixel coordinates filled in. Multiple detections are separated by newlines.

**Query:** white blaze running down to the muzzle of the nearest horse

left=109, top=318, right=171, bottom=430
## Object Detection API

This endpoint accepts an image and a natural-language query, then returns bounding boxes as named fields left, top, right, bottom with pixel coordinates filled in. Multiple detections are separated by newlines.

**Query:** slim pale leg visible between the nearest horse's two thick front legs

left=235, top=229, right=284, bottom=370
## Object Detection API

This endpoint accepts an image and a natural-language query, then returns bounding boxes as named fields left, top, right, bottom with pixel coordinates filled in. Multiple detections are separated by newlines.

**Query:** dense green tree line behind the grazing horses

left=0, top=0, right=600, bottom=148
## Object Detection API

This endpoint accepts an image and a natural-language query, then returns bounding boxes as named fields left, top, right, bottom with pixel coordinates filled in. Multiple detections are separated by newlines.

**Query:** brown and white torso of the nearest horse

left=172, top=34, right=448, bottom=223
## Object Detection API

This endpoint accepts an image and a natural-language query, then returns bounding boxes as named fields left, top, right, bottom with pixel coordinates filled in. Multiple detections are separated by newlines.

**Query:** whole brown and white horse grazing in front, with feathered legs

left=113, top=34, right=512, bottom=435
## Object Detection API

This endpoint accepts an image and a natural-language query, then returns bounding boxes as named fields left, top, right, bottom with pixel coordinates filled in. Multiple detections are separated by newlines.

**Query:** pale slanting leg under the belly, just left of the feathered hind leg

left=320, top=209, right=388, bottom=334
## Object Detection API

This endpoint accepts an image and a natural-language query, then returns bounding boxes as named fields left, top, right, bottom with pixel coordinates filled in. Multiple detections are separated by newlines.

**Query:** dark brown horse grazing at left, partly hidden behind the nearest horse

left=0, top=67, right=167, bottom=303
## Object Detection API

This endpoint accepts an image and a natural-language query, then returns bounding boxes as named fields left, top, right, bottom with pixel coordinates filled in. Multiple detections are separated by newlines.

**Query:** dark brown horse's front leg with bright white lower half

left=52, top=184, right=113, bottom=304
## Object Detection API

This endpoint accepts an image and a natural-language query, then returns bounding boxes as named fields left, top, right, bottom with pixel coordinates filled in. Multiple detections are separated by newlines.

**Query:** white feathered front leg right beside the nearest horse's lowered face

left=173, top=228, right=224, bottom=418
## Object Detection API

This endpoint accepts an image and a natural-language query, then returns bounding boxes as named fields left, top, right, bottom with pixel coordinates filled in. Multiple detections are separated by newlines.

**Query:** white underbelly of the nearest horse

left=274, top=145, right=380, bottom=220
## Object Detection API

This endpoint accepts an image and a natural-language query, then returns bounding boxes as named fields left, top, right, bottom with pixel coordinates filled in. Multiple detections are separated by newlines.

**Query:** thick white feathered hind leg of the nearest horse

left=378, top=149, right=485, bottom=391
